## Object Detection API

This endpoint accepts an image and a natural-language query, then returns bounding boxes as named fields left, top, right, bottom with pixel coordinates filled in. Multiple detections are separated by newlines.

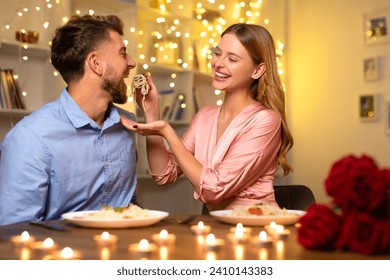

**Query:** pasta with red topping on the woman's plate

left=232, top=204, right=297, bottom=216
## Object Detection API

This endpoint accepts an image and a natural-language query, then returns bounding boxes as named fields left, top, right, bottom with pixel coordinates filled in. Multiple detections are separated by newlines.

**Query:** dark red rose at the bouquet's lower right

left=335, top=212, right=389, bottom=255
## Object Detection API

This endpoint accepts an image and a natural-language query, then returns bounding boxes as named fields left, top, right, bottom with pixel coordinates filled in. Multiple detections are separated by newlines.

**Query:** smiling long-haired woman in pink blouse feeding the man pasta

left=122, top=24, right=293, bottom=211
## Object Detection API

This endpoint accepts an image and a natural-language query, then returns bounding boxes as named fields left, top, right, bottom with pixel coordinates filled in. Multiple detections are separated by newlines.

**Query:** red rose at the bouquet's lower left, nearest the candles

left=298, top=204, right=341, bottom=250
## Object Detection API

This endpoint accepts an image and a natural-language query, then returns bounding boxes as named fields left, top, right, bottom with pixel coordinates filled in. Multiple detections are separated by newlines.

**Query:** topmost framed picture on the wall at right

left=364, top=9, right=390, bottom=45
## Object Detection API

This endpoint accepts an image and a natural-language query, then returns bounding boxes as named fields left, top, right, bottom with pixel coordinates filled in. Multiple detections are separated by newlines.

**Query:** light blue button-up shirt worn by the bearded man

left=0, top=89, right=137, bottom=225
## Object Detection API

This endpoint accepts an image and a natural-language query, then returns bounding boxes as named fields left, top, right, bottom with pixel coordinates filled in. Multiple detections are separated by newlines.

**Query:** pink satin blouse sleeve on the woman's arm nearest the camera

left=195, top=110, right=281, bottom=203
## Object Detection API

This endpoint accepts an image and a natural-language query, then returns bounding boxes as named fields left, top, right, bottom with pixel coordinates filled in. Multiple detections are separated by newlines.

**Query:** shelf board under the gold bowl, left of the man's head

left=0, top=40, right=50, bottom=59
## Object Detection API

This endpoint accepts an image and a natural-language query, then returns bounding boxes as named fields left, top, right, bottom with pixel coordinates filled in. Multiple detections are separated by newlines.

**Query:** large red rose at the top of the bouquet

left=325, top=155, right=388, bottom=213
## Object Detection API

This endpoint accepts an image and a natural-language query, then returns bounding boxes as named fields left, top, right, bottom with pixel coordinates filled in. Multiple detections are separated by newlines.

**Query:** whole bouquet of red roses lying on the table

left=298, top=155, right=390, bottom=254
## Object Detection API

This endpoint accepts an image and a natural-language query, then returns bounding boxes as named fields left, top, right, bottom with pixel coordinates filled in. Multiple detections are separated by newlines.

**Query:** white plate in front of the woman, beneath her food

left=210, top=210, right=306, bottom=226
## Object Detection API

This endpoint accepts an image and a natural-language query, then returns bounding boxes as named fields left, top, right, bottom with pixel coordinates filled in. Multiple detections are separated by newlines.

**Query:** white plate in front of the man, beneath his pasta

left=62, top=210, right=169, bottom=228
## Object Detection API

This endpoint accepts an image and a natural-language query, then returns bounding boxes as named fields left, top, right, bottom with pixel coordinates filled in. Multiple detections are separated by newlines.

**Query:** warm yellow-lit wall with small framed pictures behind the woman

left=285, top=0, right=390, bottom=202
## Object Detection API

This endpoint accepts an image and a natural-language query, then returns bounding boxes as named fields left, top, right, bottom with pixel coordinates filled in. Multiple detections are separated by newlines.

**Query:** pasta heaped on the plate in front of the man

left=74, top=204, right=152, bottom=220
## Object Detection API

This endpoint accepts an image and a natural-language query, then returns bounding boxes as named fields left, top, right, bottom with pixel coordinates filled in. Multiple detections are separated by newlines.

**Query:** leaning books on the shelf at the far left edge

left=0, top=69, right=25, bottom=109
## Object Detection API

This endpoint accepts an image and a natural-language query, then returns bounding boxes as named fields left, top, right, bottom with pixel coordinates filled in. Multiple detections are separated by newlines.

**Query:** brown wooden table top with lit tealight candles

left=0, top=215, right=390, bottom=260
